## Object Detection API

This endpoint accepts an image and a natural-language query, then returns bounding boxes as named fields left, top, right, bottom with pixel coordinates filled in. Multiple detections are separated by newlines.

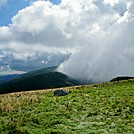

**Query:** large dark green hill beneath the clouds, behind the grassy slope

left=0, top=67, right=79, bottom=94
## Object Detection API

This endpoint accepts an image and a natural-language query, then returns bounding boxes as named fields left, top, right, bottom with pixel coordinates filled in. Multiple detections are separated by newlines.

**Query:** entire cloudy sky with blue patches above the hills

left=0, top=0, right=134, bottom=82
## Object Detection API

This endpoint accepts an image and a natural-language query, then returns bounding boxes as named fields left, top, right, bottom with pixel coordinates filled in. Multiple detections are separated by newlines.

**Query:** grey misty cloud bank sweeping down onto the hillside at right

left=59, top=1, right=134, bottom=82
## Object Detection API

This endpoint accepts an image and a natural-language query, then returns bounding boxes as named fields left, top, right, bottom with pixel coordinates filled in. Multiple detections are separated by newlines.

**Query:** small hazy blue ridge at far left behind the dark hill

left=0, top=74, right=20, bottom=84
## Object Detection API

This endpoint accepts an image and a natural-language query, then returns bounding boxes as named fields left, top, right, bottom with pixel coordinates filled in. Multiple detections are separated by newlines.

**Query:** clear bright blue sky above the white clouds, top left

left=0, top=0, right=60, bottom=26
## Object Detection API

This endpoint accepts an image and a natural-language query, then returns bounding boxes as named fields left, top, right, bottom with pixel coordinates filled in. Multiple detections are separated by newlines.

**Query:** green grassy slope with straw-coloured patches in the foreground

left=0, top=80, right=134, bottom=134
